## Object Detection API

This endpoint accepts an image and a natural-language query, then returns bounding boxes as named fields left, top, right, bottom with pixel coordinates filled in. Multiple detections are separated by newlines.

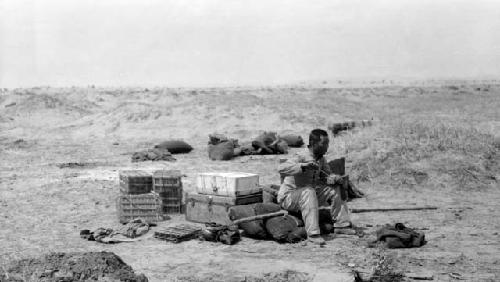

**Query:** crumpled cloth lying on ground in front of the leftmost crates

left=80, top=218, right=149, bottom=243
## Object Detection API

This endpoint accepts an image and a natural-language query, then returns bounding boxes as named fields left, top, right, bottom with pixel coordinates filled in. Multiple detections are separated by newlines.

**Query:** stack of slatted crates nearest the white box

left=153, top=170, right=182, bottom=214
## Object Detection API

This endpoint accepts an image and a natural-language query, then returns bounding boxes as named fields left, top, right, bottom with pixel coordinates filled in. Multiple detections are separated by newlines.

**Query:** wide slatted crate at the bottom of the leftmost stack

left=117, top=193, right=163, bottom=223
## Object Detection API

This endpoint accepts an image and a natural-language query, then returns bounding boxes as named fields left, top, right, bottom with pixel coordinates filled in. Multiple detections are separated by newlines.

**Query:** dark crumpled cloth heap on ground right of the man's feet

left=376, top=223, right=426, bottom=249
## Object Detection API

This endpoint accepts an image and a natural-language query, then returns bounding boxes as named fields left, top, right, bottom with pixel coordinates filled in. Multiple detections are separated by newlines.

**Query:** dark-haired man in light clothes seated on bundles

left=278, top=129, right=351, bottom=245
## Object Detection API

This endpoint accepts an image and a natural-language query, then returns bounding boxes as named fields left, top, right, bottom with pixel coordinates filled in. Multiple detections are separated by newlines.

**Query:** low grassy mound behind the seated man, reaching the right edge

left=343, top=119, right=500, bottom=188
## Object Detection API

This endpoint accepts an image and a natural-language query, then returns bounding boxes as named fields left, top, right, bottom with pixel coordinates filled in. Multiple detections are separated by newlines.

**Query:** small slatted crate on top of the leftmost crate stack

left=119, top=170, right=153, bottom=195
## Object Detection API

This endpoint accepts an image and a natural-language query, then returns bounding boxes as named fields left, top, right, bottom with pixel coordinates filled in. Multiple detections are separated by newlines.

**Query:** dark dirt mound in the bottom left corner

left=0, top=252, right=148, bottom=282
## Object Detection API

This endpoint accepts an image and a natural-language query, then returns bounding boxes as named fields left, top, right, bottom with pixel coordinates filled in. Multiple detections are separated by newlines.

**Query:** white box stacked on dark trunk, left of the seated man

left=186, top=172, right=262, bottom=225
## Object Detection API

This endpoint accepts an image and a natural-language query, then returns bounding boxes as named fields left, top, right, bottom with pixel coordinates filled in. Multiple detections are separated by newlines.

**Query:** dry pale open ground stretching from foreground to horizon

left=0, top=83, right=500, bottom=281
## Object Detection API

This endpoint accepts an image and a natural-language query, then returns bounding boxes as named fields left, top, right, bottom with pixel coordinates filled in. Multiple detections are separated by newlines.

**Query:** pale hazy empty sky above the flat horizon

left=0, top=0, right=500, bottom=87
